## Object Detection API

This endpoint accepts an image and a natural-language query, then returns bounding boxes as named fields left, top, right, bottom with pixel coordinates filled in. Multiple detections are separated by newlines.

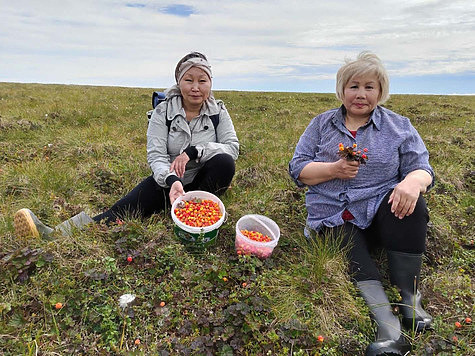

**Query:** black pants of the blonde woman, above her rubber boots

left=320, top=192, right=429, bottom=282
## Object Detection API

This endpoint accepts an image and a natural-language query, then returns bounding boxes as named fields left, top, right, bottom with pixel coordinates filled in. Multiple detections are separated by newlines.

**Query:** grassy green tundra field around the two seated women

left=0, top=83, right=475, bottom=355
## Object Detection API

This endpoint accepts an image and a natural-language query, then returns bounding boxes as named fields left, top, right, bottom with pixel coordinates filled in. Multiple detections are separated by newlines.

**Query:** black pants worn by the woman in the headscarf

left=93, top=153, right=235, bottom=224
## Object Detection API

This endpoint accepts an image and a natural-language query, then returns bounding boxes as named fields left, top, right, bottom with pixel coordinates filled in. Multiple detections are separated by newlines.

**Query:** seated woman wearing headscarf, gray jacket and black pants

left=14, top=52, right=239, bottom=237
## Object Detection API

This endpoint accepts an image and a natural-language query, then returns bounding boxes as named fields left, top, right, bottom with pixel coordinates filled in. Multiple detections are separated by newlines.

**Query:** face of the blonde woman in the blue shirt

left=343, top=74, right=381, bottom=119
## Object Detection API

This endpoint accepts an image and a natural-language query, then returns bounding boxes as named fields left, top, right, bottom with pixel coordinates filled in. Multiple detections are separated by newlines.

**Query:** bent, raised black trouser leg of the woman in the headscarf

left=185, top=153, right=236, bottom=196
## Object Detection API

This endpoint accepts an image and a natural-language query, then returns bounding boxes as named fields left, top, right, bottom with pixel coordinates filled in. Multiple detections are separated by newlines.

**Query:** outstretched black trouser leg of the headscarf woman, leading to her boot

left=93, top=176, right=169, bottom=224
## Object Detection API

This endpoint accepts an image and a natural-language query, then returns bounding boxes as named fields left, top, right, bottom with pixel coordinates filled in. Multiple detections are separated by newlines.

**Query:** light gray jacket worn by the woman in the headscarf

left=147, top=96, right=239, bottom=188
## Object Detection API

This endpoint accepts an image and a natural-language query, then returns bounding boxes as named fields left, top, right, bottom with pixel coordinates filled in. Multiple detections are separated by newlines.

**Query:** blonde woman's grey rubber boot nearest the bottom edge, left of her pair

left=356, top=280, right=411, bottom=356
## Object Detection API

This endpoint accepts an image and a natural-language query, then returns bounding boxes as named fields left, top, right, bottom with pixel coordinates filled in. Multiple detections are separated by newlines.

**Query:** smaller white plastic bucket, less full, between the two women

left=235, top=214, right=280, bottom=259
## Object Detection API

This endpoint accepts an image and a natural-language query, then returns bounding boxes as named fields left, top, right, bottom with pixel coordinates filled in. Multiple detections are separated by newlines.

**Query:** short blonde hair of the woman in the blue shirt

left=336, top=51, right=389, bottom=104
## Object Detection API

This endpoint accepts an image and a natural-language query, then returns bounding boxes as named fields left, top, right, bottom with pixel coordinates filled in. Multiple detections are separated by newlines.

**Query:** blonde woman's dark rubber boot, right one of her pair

left=388, top=251, right=432, bottom=332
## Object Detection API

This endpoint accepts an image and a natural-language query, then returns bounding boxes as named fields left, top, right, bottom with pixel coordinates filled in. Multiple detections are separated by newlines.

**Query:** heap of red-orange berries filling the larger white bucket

left=174, top=199, right=223, bottom=227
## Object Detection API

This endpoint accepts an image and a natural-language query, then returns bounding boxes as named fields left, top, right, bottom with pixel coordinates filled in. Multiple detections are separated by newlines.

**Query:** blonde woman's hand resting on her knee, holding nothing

left=388, top=179, right=420, bottom=219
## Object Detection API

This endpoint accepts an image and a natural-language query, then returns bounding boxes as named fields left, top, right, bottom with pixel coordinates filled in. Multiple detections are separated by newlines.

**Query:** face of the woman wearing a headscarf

left=178, top=67, right=211, bottom=110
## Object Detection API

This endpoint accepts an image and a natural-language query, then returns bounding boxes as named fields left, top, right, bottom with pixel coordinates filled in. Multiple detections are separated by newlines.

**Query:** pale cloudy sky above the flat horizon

left=0, top=0, right=475, bottom=94
